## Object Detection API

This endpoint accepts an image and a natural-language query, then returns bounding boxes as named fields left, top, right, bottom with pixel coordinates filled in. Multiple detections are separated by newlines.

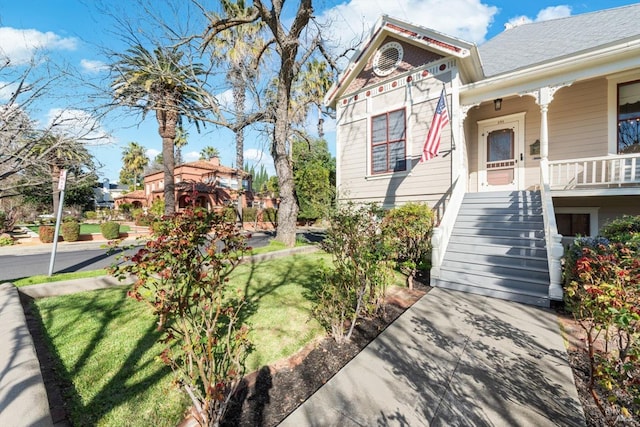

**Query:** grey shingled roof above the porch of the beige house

left=478, top=4, right=640, bottom=77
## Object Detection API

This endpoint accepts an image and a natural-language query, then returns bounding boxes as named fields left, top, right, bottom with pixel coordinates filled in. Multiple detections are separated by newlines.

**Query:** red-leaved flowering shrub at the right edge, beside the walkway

left=565, top=238, right=640, bottom=421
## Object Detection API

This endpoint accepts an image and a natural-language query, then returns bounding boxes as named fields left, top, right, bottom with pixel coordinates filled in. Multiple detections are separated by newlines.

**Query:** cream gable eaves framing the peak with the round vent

left=324, top=15, right=482, bottom=108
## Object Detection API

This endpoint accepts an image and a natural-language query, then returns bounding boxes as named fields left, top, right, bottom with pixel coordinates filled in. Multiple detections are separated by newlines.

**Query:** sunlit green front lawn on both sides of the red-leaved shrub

left=35, top=253, right=330, bottom=426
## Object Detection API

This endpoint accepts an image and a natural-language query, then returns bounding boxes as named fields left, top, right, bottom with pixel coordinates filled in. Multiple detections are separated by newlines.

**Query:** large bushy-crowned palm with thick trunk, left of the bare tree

left=111, top=45, right=207, bottom=215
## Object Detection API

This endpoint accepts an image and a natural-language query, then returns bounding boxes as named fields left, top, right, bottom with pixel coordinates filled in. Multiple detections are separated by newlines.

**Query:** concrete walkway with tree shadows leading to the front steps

left=281, top=288, right=585, bottom=427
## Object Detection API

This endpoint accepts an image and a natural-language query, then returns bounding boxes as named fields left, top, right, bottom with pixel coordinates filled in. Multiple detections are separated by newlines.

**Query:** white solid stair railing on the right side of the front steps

left=540, top=159, right=564, bottom=301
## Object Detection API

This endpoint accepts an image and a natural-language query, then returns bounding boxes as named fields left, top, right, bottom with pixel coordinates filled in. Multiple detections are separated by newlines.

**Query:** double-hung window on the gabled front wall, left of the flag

left=371, top=108, right=407, bottom=174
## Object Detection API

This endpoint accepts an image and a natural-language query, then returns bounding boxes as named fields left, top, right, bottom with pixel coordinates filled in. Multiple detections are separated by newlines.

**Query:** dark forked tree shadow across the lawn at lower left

left=23, top=289, right=182, bottom=425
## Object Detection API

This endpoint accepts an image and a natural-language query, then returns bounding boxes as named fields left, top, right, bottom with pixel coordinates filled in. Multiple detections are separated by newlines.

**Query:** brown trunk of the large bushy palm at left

left=156, top=110, right=178, bottom=215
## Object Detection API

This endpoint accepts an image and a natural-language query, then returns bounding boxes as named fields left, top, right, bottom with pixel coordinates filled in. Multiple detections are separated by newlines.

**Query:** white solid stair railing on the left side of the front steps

left=431, top=175, right=465, bottom=279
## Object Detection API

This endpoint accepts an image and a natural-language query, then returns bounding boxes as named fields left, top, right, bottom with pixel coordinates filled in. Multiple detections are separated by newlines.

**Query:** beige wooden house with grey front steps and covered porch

left=325, top=4, right=640, bottom=306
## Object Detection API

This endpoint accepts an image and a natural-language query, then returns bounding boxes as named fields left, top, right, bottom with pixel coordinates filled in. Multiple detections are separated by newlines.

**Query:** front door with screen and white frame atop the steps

left=478, top=113, right=524, bottom=191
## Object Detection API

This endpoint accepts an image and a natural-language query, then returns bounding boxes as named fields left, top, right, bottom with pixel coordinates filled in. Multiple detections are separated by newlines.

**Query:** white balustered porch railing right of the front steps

left=549, top=153, right=640, bottom=190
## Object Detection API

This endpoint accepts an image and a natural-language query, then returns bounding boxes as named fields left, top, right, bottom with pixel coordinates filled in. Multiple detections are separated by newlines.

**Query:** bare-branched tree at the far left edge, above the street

left=0, top=59, right=104, bottom=204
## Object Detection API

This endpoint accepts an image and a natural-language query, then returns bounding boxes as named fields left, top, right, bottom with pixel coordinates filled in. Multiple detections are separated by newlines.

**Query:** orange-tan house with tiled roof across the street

left=116, top=157, right=273, bottom=210
